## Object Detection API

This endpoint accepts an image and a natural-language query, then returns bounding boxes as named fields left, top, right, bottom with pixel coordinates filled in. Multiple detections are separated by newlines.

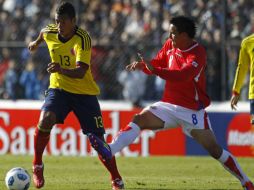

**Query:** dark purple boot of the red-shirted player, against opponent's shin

left=87, top=133, right=112, bottom=160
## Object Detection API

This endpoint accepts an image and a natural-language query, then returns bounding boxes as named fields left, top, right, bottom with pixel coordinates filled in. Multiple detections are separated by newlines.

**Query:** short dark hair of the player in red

left=170, top=16, right=197, bottom=38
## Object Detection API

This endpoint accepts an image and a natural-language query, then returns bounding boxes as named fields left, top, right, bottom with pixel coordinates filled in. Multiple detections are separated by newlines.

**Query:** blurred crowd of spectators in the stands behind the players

left=0, top=0, right=254, bottom=106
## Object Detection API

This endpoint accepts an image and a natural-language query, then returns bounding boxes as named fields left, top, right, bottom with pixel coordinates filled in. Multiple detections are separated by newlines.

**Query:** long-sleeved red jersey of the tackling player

left=143, top=39, right=210, bottom=110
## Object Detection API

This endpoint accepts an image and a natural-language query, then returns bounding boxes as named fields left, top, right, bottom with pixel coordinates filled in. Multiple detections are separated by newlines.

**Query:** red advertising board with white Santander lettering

left=0, top=109, right=185, bottom=156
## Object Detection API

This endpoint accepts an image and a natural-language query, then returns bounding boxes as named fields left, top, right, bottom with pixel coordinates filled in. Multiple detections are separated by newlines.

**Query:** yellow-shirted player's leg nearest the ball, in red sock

left=33, top=89, right=70, bottom=188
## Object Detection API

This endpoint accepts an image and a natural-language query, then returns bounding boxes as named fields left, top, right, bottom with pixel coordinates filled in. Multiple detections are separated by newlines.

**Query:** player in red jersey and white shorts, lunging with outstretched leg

left=91, top=16, right=254, bottom=190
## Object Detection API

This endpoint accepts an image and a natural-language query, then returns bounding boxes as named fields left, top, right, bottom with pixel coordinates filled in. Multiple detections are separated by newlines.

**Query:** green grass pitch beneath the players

left=0, top=155, right=254, bottom=190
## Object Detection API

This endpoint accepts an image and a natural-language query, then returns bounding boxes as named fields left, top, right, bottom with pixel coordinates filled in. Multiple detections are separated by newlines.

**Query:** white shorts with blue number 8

left=145, top=102, right=212, bottom=137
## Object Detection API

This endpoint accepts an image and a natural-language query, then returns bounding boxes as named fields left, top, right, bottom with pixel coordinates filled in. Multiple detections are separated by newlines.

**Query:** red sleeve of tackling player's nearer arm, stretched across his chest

left=153, top=47, right=206, bottom=82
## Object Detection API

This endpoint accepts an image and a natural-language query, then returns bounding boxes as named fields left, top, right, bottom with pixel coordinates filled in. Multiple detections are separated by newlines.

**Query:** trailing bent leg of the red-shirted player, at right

left=191, top=129, right=254, bottom=190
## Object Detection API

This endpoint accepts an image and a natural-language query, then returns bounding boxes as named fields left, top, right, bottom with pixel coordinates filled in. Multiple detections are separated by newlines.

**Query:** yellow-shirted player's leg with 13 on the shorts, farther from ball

left=72, top=95, right=124, bottom=190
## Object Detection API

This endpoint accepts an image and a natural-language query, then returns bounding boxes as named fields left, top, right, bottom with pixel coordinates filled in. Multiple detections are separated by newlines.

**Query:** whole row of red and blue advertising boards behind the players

left=0, top=102, right=254, bottom=157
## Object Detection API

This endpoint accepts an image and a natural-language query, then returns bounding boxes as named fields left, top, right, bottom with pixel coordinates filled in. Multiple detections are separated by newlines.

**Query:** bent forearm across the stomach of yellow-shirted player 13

left=47, top=62, right=89, bottom=79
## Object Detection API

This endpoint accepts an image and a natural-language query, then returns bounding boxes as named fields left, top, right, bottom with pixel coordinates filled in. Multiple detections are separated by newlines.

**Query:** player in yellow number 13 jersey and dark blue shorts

left=28, top=2, right=124, bottom=190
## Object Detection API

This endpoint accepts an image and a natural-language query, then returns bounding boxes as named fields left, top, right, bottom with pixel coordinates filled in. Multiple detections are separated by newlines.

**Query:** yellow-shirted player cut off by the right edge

left=231, top=34, right=254, bottom=123
